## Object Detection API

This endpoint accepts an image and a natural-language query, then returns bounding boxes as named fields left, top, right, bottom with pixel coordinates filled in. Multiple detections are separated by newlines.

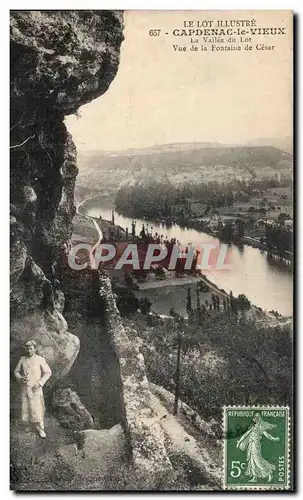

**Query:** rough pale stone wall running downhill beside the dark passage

left=100, top=275, right=172, bottom=481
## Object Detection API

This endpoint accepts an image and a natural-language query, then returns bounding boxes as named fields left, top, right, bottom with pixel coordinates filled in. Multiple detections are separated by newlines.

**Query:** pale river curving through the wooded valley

left=83, top=198, right=293, bottom=316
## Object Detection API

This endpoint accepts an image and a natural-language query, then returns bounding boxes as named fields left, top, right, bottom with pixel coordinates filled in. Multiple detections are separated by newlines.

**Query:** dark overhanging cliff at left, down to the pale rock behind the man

left=10, top=11, right=123, bottom=378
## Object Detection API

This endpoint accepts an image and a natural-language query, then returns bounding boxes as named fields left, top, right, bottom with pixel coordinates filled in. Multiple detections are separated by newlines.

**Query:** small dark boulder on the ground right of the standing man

left=52, top=388, right=94, bottom=431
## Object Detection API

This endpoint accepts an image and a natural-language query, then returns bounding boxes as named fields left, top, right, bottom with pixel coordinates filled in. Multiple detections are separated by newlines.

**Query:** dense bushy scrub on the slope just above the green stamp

left=124, top=310, right=293, bottom=422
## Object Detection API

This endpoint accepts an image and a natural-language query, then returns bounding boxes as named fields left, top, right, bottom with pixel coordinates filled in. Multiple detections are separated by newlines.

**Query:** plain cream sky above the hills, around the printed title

left=66, top=11, right=292, bottom=150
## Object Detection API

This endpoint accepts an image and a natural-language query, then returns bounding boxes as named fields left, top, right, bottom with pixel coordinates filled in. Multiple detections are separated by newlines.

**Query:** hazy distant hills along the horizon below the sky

left=77, top=143, right=293, bottom=191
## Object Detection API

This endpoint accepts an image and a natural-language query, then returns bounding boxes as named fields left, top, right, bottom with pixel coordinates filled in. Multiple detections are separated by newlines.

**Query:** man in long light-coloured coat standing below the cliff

left=14, top=340, right=52, bottom=438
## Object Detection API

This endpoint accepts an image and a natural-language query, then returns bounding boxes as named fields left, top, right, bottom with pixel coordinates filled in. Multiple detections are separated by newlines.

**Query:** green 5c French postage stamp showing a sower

left=223, top=406, right=290, bottom=490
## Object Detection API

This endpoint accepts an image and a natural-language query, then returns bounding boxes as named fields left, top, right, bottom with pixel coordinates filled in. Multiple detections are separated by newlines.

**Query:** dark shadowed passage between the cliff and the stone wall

left=59, top=270, right=123, bottom=429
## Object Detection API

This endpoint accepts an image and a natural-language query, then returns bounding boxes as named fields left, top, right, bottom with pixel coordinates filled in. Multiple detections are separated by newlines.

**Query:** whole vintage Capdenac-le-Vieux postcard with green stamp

left=10, top=10, right=295, bottom=493
